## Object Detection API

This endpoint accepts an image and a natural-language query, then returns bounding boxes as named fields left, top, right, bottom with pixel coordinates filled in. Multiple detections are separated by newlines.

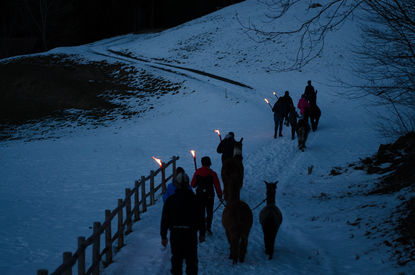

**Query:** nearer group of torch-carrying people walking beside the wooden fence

left=160, top=132, right=235, bottom=275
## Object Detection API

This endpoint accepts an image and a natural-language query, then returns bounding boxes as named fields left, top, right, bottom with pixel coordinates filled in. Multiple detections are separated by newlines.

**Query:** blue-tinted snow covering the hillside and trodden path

left=0, top=0, right=415, bottom=275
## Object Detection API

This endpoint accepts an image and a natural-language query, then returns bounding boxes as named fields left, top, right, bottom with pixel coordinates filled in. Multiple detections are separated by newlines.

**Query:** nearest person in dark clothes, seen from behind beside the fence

left=160, top=173, right=205, bottom=275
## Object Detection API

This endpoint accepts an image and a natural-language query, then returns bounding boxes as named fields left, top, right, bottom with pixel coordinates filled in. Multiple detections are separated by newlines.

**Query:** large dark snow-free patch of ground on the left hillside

left=0, top=55, right=182, bottom=140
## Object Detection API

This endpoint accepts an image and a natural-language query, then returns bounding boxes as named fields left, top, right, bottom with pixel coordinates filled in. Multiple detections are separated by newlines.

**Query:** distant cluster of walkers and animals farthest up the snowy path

left=272, top=80, right=319, bottom=150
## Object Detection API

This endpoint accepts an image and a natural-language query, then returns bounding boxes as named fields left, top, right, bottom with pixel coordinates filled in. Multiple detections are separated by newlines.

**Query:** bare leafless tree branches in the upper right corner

left=241, top=0, right=415, bottom=135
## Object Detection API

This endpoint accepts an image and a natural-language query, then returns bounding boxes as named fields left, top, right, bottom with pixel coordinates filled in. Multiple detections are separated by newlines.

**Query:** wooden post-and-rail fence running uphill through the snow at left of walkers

left=37, top=156, right=179, bottom=275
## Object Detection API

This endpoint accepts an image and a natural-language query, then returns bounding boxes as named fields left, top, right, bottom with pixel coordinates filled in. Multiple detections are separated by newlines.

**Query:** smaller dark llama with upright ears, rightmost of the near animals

left=259, top=181, right=282, bottom=260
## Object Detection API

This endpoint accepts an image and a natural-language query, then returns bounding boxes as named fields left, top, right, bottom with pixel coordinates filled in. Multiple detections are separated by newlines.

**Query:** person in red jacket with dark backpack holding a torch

left=190, top=157, right=222, bottom=234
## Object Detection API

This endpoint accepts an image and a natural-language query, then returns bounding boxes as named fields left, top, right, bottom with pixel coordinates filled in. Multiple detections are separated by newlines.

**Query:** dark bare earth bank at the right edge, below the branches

left=330, top=132, right=415, bottom=265
